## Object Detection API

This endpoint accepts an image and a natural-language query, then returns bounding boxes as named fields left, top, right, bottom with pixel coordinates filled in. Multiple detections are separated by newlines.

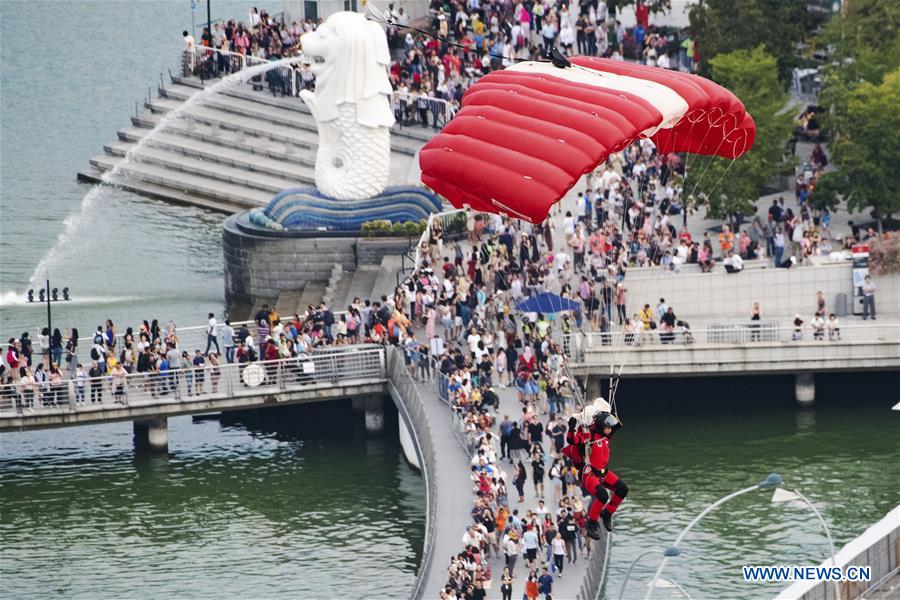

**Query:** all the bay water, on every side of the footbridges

left=0, top=0, right=900, bottom=598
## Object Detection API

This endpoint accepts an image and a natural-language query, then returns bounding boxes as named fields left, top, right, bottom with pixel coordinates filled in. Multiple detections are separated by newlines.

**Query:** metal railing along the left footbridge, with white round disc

left=0, top=344, right=385, bottom=420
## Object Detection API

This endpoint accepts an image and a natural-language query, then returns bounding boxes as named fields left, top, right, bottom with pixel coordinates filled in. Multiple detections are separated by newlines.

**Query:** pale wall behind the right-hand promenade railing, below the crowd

left=624, top=261, right=900, bottom=322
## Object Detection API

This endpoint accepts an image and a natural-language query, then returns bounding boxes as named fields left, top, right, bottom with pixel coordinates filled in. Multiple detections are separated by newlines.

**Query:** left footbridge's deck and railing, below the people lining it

left=0, top=346, right=387, bottom=436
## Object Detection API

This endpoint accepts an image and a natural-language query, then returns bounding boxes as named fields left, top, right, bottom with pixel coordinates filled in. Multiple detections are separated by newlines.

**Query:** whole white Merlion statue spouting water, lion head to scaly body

left=300, top=12, right=394, bottom=200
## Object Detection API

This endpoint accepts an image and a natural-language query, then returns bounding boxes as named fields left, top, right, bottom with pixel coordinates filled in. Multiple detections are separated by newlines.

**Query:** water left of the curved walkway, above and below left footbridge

left=0, top=0, right=425, bottom=598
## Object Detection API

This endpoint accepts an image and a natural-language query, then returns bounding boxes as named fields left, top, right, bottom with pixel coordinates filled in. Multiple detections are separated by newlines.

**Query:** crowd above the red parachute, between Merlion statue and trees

left=387, top=0, right=699, bottom=125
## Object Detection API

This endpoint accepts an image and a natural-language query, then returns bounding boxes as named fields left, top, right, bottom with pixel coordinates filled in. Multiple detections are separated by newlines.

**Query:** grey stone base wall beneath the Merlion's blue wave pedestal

left=222, top=215, right=409, bottom=307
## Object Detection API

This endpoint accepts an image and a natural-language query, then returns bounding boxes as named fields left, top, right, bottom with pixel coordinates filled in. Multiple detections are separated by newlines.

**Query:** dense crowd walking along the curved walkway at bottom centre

left=431, top=314, right=591, bottom=600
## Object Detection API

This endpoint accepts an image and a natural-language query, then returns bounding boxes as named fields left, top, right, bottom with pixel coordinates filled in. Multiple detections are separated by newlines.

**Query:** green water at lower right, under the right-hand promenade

left=605, top=373, right=900, bottom=599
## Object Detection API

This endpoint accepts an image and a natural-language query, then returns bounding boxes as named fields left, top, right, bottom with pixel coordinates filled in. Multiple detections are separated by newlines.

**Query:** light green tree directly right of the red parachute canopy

left=687, top=46, right=794, bottom=219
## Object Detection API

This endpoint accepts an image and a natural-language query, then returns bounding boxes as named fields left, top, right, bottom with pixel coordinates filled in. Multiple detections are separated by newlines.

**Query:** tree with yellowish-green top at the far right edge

left=813, top=68, right=900, bottom=232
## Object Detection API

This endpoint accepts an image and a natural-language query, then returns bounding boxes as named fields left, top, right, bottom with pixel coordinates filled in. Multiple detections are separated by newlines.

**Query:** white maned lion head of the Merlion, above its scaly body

left=300, top=12, right=394, bottom=127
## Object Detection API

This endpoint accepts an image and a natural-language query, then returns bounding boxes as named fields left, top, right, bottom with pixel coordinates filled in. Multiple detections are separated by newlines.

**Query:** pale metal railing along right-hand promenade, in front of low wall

left=568, top=320, right=900, bottom=360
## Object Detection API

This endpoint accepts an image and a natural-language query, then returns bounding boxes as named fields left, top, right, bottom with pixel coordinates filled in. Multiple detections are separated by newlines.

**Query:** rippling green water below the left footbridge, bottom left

left=0, top=403, right=425, bottom=598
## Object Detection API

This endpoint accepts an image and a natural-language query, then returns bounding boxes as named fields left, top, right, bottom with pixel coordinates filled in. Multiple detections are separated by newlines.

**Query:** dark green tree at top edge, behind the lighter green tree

left=689, top=0, right=809, bottom=82
